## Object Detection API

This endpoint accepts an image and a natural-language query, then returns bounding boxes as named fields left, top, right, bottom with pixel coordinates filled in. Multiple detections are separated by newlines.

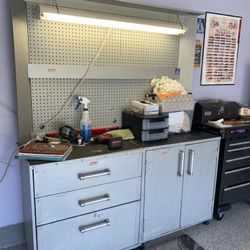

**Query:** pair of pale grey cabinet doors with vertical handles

left=143, top=139, right=219, bottom=241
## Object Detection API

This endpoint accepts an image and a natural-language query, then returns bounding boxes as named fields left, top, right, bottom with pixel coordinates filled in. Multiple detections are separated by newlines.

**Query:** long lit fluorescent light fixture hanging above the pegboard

left=40, top=5, right=186, bottom=35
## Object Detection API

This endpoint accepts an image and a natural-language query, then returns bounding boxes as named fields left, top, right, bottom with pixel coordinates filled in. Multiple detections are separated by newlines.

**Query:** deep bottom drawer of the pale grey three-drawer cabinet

left=37, top=202, right=140, bottom=250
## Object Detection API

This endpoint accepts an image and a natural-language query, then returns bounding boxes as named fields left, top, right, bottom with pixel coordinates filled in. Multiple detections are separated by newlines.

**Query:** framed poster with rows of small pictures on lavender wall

left=201, top=12, right=241, bottom=86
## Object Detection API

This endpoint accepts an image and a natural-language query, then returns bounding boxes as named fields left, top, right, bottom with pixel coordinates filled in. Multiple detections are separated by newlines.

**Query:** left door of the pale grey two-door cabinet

left=144, top=147, right=184, bottom=241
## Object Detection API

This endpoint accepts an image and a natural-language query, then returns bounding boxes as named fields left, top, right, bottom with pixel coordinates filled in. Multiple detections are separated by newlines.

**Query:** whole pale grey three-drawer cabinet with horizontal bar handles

left=22, top=149, right=143, bottom=250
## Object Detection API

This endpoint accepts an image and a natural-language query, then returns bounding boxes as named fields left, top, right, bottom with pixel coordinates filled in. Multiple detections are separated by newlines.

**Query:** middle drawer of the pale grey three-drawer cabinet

left=36, top=178, right=141, bottom=225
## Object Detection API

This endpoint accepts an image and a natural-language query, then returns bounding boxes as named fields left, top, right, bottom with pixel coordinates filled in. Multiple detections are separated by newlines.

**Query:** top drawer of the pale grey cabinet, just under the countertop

left=34, top=152, right=142, bottom=197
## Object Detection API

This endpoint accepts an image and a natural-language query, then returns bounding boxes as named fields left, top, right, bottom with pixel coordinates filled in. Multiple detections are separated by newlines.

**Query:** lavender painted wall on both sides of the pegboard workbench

left=0, top=0, right=250, bottom=227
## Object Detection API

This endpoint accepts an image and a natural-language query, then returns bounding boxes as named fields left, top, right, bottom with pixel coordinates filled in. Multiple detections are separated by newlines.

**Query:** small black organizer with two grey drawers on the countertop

left=122, top=111, right=168, bottom=142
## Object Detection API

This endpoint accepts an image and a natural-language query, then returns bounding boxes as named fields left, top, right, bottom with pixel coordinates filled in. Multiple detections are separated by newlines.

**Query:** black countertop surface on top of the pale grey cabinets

left=29, top=130, right=218, bottom=165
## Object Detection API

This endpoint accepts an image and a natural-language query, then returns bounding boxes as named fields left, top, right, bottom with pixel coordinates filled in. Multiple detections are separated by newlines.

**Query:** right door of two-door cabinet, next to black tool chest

left=181, top=141, right=218, bottom=227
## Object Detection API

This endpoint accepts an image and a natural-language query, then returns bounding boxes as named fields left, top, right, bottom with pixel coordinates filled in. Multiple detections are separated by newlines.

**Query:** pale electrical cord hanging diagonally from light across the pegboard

left=39, top=28, right=112, bottom=130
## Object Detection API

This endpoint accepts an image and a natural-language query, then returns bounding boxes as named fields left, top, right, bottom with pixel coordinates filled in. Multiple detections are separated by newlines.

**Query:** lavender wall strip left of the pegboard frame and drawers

left=0, top=0, right=23, bottom=227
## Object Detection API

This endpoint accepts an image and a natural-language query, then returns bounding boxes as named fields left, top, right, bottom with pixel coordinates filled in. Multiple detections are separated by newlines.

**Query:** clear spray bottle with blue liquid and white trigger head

left=76, top=96, right=92, bottom=142
